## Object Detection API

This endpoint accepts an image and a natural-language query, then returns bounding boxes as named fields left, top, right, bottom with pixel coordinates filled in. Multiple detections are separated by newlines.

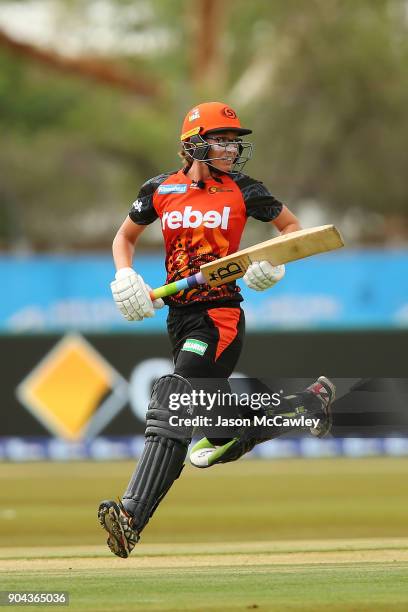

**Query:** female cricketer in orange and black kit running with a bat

left=98, top=102, right=335, bottom=557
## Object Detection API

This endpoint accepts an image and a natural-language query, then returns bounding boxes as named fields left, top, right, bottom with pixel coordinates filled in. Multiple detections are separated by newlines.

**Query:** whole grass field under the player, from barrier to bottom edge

left=0, top=458, right=408, bottom=612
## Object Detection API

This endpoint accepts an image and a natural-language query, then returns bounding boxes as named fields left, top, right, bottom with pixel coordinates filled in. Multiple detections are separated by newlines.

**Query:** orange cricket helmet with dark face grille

left=180, top=102, right=252, bottom=172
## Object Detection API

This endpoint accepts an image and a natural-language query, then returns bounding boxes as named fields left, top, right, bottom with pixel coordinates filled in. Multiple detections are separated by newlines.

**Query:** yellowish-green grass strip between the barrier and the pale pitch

left=0, top=458, right=408, bottom=546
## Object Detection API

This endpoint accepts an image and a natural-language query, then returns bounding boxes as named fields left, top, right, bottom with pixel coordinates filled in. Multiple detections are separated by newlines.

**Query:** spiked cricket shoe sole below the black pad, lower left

left=98, top=500, right=140, bottom=559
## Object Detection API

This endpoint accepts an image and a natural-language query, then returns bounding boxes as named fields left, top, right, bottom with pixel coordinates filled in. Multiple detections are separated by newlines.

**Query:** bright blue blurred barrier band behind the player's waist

left=0, top=249, right=408, bottom=333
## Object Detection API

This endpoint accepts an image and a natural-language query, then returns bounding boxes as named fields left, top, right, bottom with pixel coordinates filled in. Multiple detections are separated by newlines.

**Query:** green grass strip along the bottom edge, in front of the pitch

left=2, top=564, right=408, bottom=612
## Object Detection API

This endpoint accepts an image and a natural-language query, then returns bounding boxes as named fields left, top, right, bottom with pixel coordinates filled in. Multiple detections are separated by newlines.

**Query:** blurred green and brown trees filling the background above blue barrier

left=0, top=0, right=408, bottom=249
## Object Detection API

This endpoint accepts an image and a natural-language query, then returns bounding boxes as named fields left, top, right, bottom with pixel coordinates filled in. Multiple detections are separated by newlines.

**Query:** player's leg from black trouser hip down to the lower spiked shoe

left=98, top=308, right=244, bottom=557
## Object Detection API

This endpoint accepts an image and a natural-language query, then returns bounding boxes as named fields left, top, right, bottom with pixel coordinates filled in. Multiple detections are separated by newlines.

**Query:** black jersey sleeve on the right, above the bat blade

left=236, top=174, right=283, bottom=222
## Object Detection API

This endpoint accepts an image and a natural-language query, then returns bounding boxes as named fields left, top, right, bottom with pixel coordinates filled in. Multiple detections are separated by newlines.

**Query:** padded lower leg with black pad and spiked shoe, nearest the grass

left=98, top=374, right=191, bottom=558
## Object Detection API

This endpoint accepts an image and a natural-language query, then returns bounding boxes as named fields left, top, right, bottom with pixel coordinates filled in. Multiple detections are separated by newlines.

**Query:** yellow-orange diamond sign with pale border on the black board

left=17, top=335, right=127, bottom=440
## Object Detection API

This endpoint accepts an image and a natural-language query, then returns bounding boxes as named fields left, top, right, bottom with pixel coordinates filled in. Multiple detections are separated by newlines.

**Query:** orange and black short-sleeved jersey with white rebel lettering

left=129, top=169, right=282, bottom=307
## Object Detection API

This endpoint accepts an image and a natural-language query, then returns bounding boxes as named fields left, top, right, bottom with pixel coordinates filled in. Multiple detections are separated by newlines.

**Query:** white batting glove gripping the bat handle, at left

left=111, top=268, right=164, bottom=321
